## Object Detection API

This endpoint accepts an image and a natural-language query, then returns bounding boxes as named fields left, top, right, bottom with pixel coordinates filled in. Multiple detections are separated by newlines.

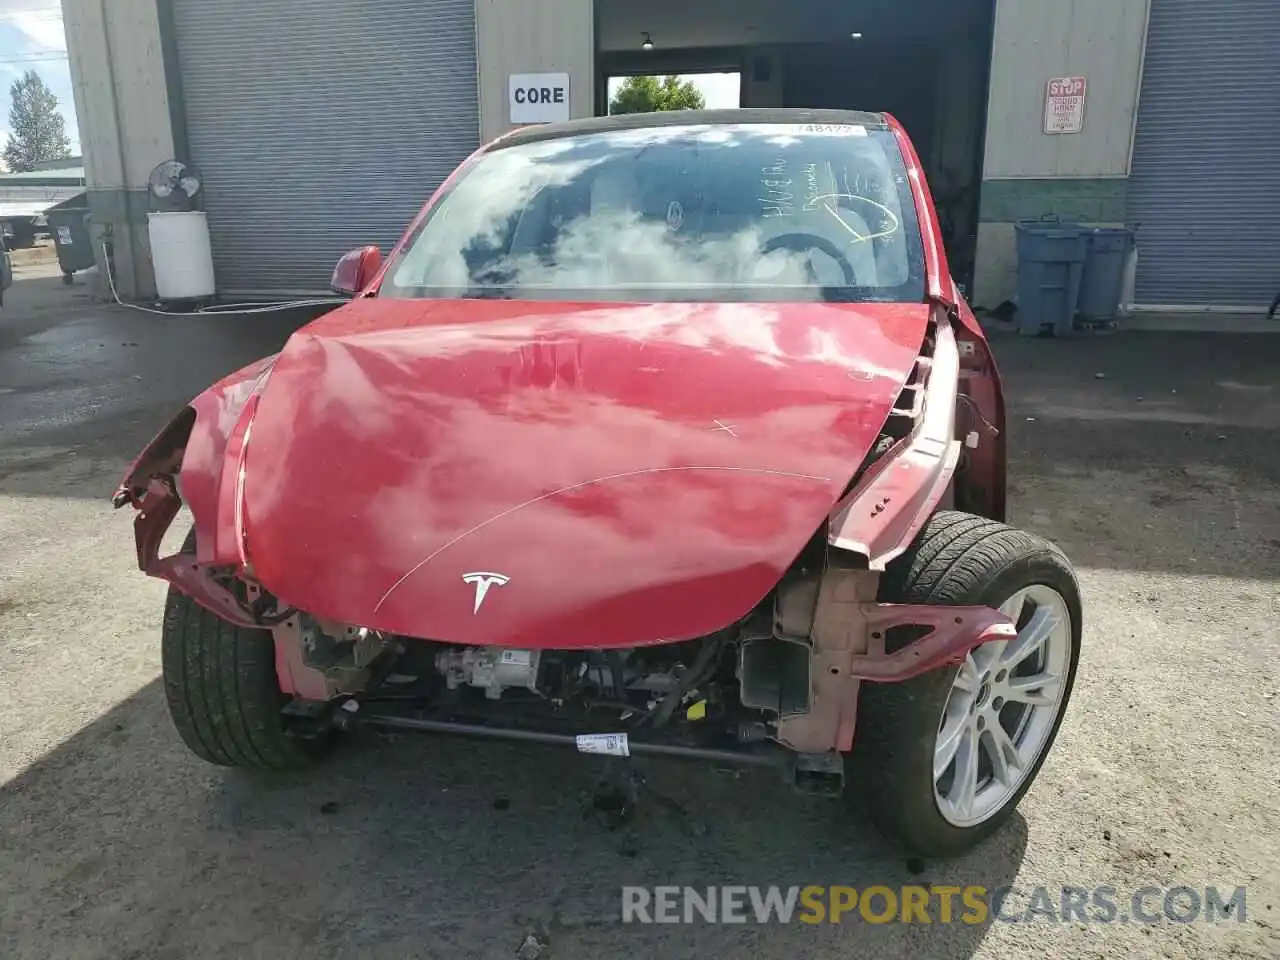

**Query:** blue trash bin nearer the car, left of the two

left=1015, top=216, right=1089, bottom=337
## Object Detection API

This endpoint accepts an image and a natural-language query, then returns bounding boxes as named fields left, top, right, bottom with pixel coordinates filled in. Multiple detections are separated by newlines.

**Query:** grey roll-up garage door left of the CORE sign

left=173, top=0, right=479, bottom=294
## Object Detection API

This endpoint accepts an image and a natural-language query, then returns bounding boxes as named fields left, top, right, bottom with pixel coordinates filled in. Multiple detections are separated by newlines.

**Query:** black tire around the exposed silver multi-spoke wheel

left=854, top=511, right=1082, bottom=858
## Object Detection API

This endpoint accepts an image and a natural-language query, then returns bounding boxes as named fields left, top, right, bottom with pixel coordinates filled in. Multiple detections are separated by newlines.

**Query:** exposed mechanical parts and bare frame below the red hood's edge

left=275, top=544, right=1011, bottom=794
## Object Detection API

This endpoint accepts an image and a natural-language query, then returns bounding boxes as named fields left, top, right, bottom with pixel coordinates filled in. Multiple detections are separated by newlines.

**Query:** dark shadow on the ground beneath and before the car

left=0, top=681, right=1027, bottom=960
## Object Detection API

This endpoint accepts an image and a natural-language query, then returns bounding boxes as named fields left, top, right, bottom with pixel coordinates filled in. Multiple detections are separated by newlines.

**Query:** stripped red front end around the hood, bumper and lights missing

left=114, top=310, right=1014, bottom=794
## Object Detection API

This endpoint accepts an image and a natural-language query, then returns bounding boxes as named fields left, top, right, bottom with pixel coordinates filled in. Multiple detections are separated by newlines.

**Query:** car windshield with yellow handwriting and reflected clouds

left=381, top=124, right=924, bottom=302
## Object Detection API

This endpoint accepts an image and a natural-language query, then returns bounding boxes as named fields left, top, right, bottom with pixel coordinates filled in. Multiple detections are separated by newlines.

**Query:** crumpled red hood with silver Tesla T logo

left=244, top=298, right=929, bottom=648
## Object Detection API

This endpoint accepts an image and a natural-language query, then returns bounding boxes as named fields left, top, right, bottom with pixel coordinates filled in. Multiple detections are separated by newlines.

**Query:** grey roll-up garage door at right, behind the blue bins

left=1129, top=0, right=1280, bottom=306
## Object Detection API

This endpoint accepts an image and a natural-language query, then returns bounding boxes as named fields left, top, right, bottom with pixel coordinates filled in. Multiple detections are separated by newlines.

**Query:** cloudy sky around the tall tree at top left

left=0, top=0, right=81, bottom=154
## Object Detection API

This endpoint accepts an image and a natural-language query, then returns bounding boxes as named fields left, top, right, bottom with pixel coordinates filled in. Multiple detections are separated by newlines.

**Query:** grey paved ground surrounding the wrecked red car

left=0, top=268, right=1280, bottom=960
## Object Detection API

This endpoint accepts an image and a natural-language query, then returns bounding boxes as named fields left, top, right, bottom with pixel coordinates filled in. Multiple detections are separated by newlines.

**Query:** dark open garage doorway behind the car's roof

left=595, top=0, right=995, bottom=289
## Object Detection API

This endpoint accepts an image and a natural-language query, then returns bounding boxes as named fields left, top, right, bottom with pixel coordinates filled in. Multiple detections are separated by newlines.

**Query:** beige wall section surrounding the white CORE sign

left=476, top=0, right=595, bottom=142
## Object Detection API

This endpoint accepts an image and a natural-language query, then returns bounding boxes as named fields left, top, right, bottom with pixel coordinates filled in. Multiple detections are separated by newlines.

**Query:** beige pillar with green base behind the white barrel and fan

left=63, top=0, right=174, bottom=300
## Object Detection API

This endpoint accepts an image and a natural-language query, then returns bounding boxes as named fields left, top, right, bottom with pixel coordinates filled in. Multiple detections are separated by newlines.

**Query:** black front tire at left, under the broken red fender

left=161, top=531, right=332, bottom=771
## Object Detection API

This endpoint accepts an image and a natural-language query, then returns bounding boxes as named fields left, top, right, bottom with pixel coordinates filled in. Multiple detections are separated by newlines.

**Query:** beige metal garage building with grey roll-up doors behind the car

left=65, top=0, right=1280, bottom=308
